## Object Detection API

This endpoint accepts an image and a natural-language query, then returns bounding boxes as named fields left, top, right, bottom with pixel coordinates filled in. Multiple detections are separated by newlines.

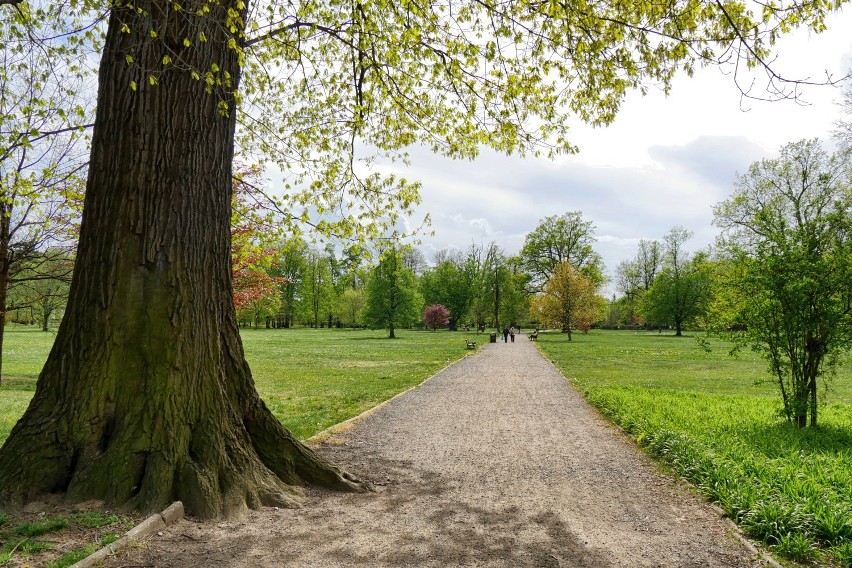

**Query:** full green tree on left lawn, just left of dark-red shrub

left=363, top=248, right=423, bottom=339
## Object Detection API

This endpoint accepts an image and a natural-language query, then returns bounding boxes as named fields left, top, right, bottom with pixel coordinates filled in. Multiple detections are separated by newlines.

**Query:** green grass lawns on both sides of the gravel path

left=0, top=327, right=852, bottom=567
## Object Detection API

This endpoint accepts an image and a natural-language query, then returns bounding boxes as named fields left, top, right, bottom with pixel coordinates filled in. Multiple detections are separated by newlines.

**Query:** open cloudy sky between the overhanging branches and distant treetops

left=386, top=7, right=852, bottom=292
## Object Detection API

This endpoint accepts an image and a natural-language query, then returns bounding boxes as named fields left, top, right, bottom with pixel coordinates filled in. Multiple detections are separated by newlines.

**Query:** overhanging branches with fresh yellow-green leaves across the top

left=3, top=0, right=842, bottom=246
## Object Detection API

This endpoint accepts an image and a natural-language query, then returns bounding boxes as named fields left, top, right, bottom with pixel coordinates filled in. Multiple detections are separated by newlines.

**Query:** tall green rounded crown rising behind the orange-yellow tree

left=520, top=211, right=604, bottom=288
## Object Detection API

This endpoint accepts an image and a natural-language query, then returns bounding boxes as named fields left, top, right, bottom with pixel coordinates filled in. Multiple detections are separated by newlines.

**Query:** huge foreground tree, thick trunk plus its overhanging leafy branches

left=0, top=0, right=840, bottom=517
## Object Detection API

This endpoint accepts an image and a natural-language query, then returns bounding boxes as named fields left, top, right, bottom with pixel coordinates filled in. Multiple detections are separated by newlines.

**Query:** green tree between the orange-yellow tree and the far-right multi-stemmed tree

left=642, top=227, right=712, bottom=337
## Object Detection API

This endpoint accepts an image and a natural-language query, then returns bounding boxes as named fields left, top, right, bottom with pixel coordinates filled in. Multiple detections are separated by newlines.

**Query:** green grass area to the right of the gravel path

left=539, top=331, right=852, bottom=567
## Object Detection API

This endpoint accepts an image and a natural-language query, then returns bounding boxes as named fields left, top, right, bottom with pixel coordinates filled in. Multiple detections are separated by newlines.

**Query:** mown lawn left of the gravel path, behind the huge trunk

left=0, top=326, right=476, bottom=443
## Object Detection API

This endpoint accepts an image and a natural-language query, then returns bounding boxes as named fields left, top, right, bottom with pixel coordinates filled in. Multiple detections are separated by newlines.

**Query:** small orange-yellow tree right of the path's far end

left=531, top=262, right=601, bottom=341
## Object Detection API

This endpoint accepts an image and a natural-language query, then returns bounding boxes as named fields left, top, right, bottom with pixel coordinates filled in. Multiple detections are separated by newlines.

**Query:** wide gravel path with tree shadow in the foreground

left=103, top=335, right=767, bottom=567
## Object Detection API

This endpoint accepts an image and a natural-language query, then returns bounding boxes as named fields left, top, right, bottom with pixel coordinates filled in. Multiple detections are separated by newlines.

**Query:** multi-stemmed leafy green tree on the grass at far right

left=715, top=140, right=852, bottom=427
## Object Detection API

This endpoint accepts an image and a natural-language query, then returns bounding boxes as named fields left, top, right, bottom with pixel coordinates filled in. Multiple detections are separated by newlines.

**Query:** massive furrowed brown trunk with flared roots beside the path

left=0, top=1, right=360, bottom=517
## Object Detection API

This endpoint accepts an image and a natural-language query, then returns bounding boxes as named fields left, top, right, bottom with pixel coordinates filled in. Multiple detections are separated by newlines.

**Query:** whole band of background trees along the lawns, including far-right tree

left=8, top=101, right=852, bottom=434
